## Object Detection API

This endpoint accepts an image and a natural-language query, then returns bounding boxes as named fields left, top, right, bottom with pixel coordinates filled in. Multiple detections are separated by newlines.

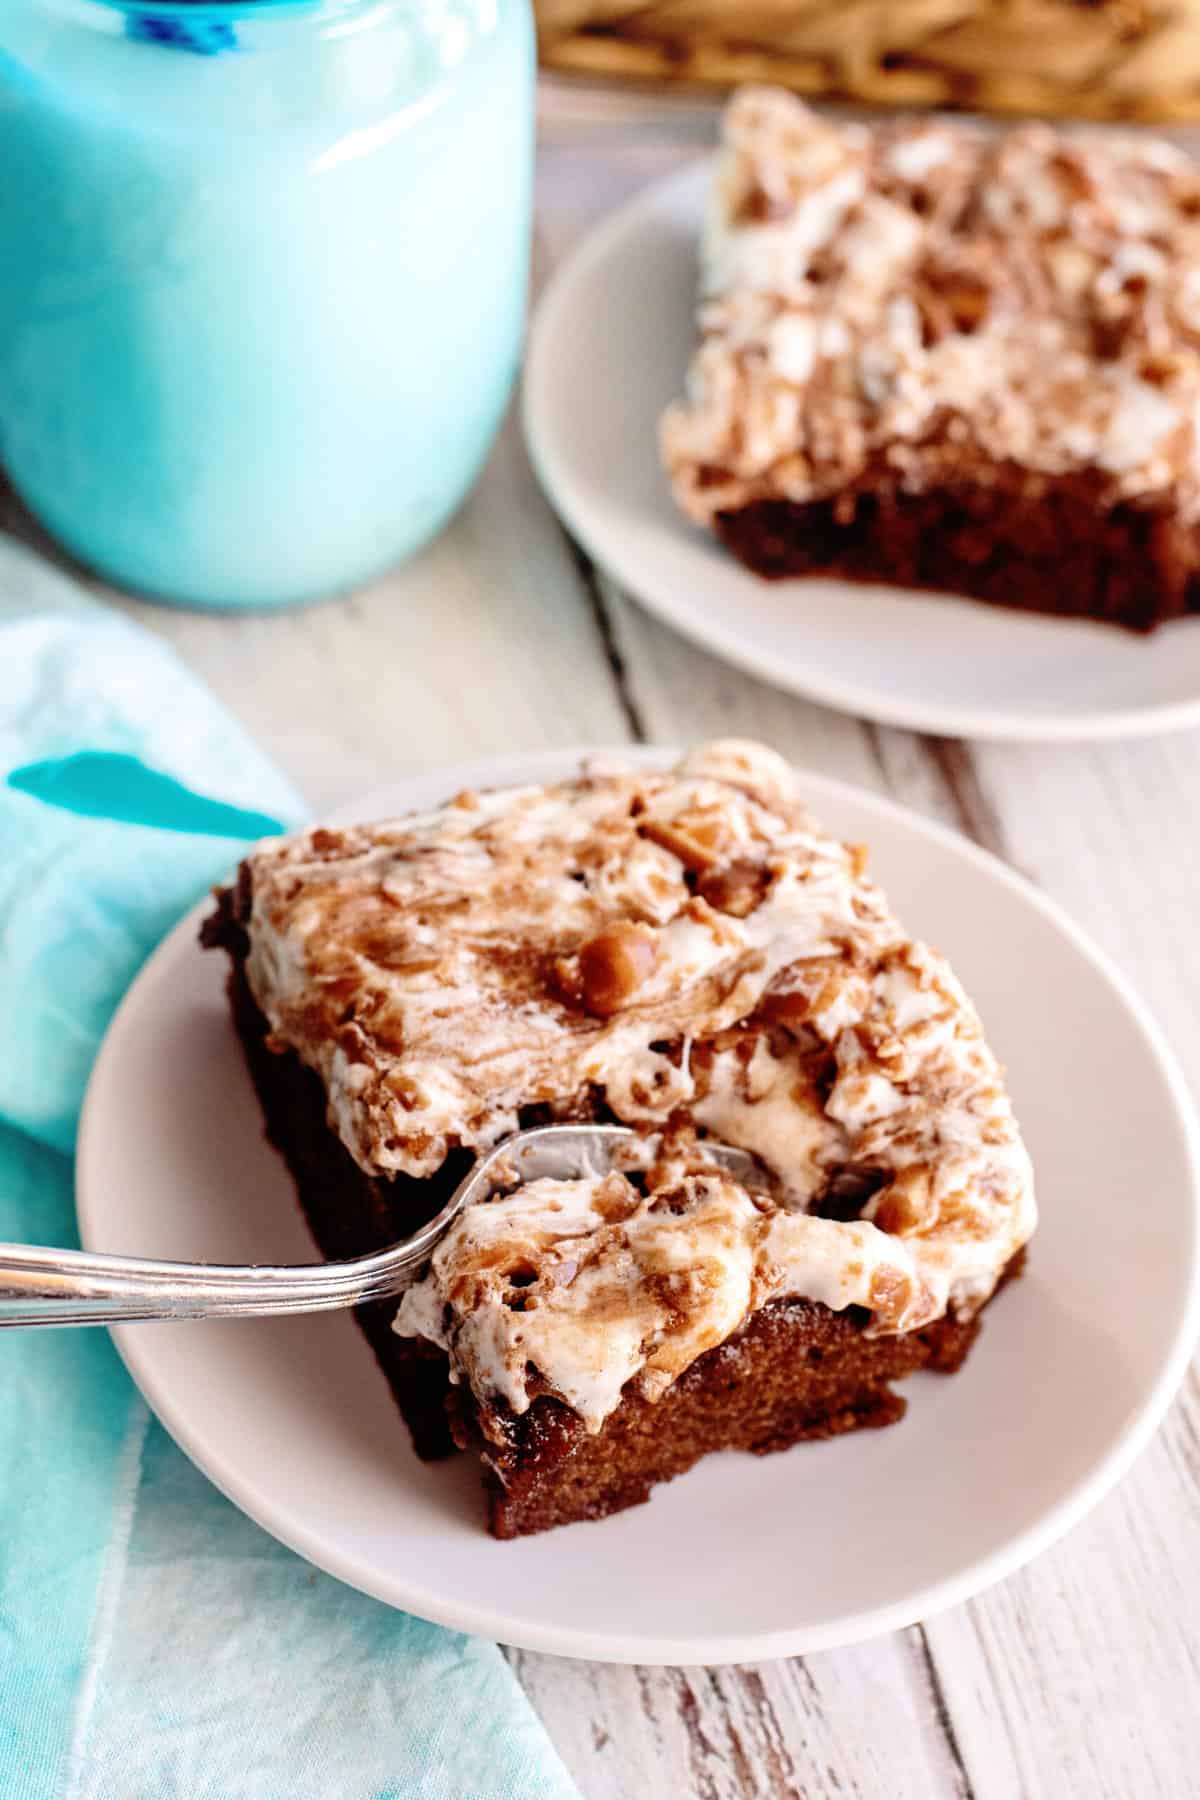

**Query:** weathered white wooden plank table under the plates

left=4, top=94, right=1200, bottom=1800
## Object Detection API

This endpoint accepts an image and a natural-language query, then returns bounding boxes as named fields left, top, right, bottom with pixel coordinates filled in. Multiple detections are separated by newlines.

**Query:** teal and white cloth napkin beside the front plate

left=0, top=538, right=576, bottom=1800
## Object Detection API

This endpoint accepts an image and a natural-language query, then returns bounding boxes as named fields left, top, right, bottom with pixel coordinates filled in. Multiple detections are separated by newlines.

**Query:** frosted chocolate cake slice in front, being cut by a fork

left=205, top=743, right=1036, bottom=1537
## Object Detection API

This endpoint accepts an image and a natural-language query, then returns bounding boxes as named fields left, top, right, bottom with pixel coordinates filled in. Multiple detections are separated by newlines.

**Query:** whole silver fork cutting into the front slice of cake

left=0, top=1125, right=759, bottom=1328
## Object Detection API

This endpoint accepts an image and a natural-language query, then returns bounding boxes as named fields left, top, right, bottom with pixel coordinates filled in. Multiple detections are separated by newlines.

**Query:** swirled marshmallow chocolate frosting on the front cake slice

left=246, top=742, right=1036, bottom=1429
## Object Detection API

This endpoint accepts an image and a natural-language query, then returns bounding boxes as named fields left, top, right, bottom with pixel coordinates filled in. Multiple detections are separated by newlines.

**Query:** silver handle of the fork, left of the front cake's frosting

left=0, top=1228, right=435, bottom=1328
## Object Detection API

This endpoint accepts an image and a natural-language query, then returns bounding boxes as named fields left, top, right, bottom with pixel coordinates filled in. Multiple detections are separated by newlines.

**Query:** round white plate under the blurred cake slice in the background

left=524, top=162, right=1200, bottom=740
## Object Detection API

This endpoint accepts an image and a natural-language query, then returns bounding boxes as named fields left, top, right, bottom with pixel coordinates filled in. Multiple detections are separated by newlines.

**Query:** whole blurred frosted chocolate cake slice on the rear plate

left=662, top=88, right=1200, bottom=630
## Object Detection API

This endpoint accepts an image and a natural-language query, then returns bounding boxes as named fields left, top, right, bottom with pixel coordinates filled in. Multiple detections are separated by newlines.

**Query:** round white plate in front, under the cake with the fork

left=79, top=752, right=1200, bottom=1663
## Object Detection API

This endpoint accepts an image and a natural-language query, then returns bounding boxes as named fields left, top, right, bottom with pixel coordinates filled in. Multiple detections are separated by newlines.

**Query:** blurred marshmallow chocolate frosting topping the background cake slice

left=660, top=88, right=1200, bottom=524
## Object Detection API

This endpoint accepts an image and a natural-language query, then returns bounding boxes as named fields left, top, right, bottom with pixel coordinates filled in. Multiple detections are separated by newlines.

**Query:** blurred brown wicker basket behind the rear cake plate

left=536, top=0, right=1200, bottom=122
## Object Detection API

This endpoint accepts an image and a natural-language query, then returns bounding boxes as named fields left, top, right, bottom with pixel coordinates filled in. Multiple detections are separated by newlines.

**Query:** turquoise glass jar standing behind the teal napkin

left=0, top=0, right=534, bottom=607
